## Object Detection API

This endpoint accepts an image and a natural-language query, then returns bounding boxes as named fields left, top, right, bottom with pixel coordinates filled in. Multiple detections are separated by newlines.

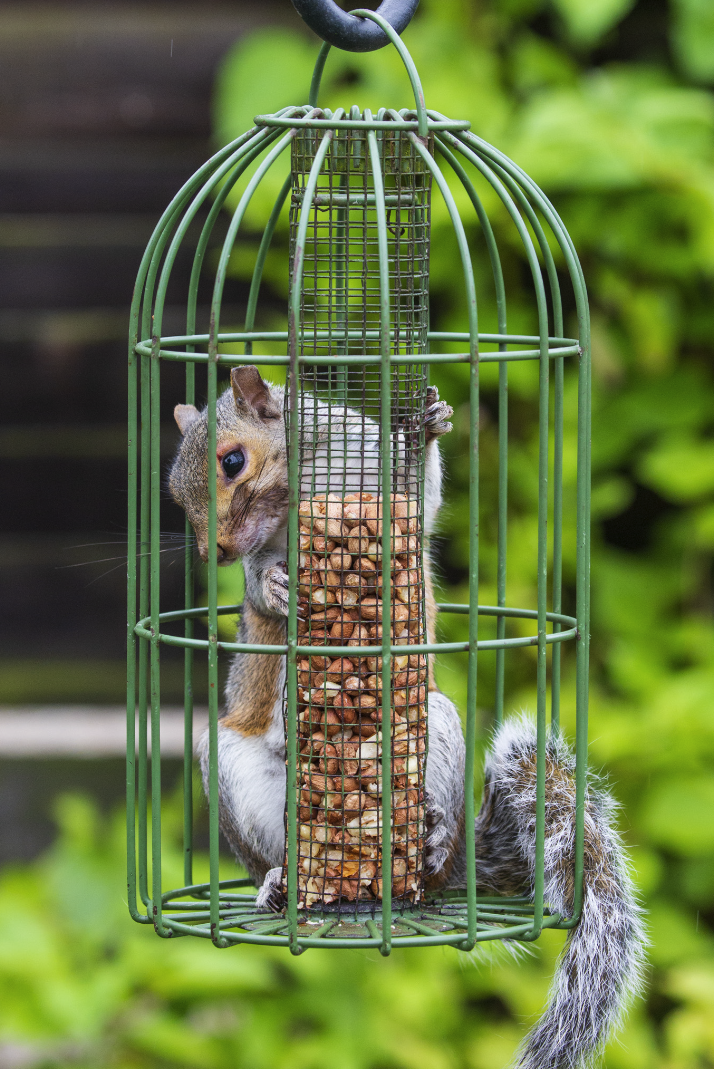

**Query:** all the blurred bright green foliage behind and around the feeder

left=5, top=0, right=714, bottom=1069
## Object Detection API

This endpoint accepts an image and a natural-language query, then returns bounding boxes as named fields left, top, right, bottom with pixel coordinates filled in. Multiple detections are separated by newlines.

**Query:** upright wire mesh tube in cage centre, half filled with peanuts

left=283, top=129, right=431, bottom=909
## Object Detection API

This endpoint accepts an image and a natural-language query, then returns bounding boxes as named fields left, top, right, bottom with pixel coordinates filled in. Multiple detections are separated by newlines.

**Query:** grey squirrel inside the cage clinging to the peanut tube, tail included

left=169, top=366, right=645, bottom=1069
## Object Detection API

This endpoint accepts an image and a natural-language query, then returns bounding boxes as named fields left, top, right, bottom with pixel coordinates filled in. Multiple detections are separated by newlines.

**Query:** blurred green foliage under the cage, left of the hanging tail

left=0, top=796, right=577, bottom=1069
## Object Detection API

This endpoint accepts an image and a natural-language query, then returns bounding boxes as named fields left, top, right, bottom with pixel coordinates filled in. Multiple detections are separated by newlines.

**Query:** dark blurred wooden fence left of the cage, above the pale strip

left=0, top=0, right=286, bottom=706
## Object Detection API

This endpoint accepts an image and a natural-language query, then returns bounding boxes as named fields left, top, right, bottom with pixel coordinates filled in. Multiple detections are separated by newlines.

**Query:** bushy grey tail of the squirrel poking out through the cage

left=476, top=717, right=647, bottom=1069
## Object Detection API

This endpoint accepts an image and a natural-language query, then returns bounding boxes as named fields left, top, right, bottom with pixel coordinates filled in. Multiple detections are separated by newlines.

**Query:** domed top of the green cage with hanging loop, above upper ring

left=133, top=0, right=589, bottom=376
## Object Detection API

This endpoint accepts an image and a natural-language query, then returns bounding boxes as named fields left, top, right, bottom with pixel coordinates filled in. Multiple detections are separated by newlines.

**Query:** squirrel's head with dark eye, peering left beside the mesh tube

left=169, top=366, right=288, bottom=564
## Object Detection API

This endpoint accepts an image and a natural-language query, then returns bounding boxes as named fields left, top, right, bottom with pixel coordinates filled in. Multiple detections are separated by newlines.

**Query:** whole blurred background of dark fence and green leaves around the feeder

left=0, top=0, right=714, bottom=1069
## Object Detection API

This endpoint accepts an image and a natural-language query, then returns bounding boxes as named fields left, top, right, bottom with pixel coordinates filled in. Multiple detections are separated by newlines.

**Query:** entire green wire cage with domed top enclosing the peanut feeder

left=127, top=11, right=590, bottom=954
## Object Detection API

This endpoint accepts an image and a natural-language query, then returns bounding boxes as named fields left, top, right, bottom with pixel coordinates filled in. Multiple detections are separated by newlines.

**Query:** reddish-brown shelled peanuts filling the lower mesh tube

left=283, top=493, right=428, bottom=907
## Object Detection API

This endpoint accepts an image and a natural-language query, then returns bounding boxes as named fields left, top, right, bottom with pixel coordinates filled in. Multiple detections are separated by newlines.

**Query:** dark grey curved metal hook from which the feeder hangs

left=293, top=0, right=419, bottom=52
